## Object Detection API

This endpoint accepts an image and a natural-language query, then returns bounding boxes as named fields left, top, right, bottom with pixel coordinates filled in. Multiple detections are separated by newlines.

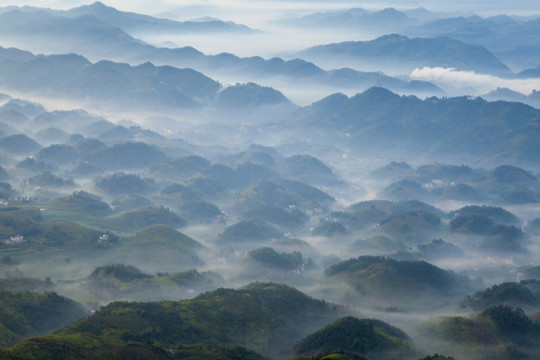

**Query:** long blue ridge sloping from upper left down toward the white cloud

left=0, top=6, right=443, bottom=94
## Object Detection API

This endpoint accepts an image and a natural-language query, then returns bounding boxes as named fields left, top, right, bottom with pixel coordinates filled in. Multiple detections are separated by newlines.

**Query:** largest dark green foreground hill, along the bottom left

left=1, top=283, right=337, bottom=359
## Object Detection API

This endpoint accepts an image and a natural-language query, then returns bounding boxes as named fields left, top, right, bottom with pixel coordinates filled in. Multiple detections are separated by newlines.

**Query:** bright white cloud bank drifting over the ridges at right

left=411, top=67, right=540, bottom=95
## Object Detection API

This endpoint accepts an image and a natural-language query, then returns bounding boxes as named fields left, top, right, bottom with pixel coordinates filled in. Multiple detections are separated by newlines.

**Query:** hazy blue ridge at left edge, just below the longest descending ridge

left=0, top=47, right=290, bottom=108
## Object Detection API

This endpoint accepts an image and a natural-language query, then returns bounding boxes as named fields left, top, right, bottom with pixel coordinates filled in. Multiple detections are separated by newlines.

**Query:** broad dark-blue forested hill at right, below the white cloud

left=293, top=87, right=540, bottom=162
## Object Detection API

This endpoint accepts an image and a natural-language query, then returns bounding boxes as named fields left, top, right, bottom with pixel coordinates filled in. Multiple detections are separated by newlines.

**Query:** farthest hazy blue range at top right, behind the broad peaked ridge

left=280, top=8, right=540, bottom=68
